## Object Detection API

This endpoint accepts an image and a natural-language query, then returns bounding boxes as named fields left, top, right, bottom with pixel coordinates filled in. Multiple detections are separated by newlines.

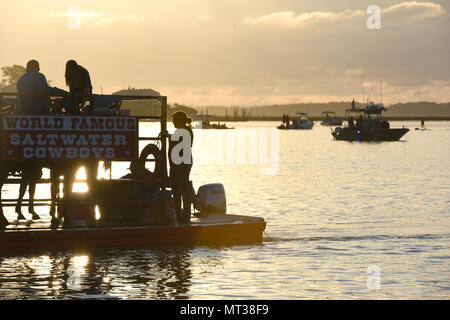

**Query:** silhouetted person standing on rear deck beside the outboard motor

left=169, top=111, right=194, bottom=223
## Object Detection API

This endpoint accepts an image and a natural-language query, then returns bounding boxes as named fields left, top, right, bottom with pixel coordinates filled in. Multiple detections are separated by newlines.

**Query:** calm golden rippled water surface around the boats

left=0, top=122, right=450, bottom=299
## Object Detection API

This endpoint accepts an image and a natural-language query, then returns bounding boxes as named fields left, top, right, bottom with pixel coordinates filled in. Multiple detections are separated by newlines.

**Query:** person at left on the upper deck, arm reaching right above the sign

left=16, top=60, right=68, bottom=115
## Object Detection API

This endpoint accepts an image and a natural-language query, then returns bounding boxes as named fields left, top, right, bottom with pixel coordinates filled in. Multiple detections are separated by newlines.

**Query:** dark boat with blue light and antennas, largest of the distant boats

left=331, top=102, right=409, bottom=141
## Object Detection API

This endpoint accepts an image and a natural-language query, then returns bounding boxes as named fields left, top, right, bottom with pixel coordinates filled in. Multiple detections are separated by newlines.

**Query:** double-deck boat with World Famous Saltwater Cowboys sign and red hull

left=0, top=93, right=266, bottom=251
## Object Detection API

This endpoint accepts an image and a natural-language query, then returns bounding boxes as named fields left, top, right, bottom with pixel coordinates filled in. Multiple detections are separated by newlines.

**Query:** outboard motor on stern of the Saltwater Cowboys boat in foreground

left=197, top=183, right=227, bottom=214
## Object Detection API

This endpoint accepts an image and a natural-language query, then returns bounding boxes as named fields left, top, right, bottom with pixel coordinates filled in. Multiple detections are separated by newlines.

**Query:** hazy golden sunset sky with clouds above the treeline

left=0, top=0, right=450, bottom=106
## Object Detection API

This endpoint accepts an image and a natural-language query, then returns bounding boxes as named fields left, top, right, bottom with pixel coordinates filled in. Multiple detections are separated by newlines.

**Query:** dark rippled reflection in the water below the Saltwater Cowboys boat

left=0, top=248, right=192, bottom=299
